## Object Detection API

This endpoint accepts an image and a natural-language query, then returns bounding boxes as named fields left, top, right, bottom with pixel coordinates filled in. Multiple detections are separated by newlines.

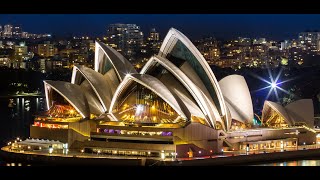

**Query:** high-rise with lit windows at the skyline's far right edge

left=299, top=31, right=320, bottom=51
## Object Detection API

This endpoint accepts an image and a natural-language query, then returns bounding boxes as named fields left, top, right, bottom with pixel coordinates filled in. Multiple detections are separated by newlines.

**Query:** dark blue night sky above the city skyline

left=0, top=14, right=320, bottom=40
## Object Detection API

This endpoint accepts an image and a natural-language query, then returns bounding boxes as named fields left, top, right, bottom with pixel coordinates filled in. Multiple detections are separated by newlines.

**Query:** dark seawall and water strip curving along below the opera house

left=0, top=146, right=320, bottom=166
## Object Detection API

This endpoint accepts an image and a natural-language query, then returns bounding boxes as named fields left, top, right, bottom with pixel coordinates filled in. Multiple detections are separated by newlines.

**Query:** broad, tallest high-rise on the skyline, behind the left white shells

left=106, top=24, right=143, bottom=60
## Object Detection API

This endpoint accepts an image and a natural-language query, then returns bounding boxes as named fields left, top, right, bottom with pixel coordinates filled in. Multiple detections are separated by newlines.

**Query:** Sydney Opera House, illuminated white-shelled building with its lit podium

left=24, top=28, right=316, bottom=157
